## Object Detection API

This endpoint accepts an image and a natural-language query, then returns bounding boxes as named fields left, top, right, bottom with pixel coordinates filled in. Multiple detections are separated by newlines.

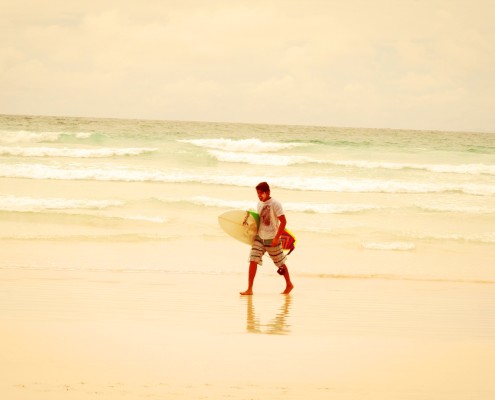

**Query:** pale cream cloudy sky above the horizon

left=0, top=0, right=495, bottom=132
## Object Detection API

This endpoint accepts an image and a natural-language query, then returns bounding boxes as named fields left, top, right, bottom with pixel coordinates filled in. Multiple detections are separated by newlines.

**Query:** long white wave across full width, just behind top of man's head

left=0, top=163, right=495, bottom=196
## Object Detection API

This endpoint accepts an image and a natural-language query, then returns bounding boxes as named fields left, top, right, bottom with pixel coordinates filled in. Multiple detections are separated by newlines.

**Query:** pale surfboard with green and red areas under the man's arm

left=218, top=210, right=296, bottom=254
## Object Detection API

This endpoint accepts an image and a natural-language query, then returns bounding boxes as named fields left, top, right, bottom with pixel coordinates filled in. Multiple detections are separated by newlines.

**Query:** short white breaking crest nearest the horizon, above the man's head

left=179, top=138, right=305, bottom=153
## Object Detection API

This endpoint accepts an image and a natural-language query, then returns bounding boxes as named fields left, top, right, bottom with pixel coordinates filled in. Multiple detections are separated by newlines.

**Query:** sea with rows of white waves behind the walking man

left=0, top=115, right=495, bottom=283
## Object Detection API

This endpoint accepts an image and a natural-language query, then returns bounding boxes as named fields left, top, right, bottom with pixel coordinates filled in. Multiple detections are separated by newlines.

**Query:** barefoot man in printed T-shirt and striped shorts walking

left=241, top=182, right=294, bottom=295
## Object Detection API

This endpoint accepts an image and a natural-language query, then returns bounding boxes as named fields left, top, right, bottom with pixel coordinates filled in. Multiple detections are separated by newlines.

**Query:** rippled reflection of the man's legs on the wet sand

left=242, top=295, right=292, bottom=335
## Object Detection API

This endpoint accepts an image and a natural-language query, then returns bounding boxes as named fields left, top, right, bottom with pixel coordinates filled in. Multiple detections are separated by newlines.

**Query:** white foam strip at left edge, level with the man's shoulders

left=0, top=196, right=123, bottom=212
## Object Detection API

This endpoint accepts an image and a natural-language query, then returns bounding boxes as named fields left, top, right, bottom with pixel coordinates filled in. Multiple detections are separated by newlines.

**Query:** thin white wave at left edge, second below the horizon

left=0, top=147, right=158, bottom=158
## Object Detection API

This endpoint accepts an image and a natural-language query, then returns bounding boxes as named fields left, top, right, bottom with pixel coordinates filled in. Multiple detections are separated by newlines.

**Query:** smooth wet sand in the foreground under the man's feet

left=0, top=239, right=495, bottom=400
